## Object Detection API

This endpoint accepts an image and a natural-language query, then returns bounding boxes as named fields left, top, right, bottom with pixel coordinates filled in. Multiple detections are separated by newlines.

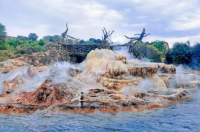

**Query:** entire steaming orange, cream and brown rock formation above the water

left=0, top=49, right=200, bottom=114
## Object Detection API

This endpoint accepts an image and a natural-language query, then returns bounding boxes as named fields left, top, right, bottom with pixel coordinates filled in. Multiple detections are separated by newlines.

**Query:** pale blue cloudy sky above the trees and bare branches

left=0, top=0, right=200, bottom=47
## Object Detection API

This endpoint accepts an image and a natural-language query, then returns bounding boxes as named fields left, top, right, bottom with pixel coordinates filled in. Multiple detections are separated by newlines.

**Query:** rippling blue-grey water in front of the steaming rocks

left=0, top=91, right=200, bottom=132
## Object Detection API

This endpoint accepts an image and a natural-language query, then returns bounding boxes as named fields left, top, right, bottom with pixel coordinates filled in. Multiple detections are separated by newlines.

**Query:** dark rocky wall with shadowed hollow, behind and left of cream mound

left=27, top=43, right=109, bottom=66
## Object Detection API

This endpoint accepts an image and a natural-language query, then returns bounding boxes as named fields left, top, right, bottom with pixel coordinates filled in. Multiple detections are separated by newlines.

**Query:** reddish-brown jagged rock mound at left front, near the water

left=11, top=80, right=76, bottom=105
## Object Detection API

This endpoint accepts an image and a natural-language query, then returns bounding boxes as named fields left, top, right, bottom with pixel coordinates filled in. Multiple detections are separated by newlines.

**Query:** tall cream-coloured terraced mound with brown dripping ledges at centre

left=78, top=49, right=169, bottom=90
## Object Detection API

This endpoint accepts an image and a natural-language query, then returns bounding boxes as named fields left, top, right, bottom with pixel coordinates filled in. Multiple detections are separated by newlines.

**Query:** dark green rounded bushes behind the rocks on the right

left=126, top=41, right=200, bottom=70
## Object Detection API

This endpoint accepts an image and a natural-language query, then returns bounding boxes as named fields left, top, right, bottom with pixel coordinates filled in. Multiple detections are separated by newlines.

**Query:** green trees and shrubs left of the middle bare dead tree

left=0, top=23, right=104, bottom=61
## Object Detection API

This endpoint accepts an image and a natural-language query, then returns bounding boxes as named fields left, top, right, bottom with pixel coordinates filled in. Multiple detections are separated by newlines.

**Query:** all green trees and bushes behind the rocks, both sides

left=0, top=23, right=200, bottom=70
